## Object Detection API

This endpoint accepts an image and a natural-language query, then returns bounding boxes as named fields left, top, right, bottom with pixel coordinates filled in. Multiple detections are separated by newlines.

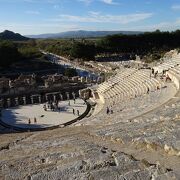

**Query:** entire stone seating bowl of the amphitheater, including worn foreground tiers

left=0, top=53, right=180, bottom=180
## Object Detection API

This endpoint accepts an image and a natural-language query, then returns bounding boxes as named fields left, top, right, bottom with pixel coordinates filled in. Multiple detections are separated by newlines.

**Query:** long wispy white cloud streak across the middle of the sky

left=49, top=12, right=153, bottom=24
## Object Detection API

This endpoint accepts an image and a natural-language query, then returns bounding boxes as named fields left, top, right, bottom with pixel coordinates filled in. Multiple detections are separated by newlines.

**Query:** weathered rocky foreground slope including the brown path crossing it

left=0, top=126, right=180, bottom=180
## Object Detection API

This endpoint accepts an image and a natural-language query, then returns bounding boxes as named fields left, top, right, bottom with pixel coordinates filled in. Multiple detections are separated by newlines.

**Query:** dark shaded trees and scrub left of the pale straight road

left=0, top=41, right=57, bottom=72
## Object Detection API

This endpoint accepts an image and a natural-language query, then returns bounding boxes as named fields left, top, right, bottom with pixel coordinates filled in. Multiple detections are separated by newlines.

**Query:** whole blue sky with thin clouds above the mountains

left=0, top=0, right=180, bottom=35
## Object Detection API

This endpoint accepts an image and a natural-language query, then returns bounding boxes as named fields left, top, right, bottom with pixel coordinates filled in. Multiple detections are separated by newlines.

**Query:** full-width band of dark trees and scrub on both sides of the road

left=0, top=30, right=180, bottom=67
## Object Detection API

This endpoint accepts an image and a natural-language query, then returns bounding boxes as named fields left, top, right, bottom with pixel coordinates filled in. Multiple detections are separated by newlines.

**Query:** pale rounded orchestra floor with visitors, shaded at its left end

left=1, top=99, right=87, bottom=129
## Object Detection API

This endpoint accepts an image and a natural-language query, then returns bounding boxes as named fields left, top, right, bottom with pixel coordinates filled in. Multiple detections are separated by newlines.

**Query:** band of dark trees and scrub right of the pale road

left=38, top=30, right=180, bottom=60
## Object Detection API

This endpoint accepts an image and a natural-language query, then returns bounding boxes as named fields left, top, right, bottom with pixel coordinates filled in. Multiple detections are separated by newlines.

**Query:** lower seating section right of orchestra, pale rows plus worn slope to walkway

left=79, top=68, right=177, bottom=125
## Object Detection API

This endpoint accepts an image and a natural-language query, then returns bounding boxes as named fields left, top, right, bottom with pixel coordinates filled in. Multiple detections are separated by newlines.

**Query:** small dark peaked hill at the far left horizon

left=0, top=30, right=29, bottom=41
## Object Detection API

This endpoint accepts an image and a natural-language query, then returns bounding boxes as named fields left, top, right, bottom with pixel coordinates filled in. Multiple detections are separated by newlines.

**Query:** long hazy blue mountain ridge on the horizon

left=27, top=30, right=142, bottom=39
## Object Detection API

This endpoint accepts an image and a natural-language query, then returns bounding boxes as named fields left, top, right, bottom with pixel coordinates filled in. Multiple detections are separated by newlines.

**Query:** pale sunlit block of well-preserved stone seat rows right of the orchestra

left=97, top=68, right=164, bottom=104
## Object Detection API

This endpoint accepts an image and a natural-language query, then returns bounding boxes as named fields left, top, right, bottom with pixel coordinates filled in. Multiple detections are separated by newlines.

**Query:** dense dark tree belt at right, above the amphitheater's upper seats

left=98, top=30, right=180, bottom=54
